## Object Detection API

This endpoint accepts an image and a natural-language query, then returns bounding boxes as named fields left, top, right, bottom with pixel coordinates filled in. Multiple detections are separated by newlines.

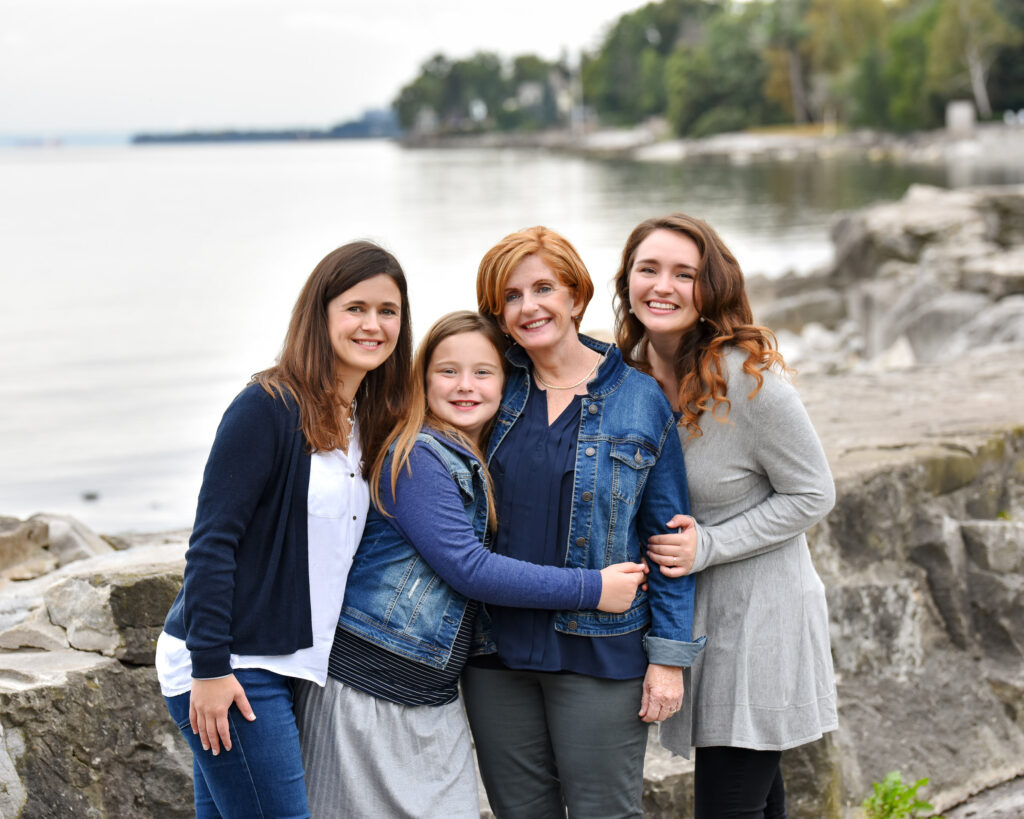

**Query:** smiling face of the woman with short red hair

left=499, top=256, right=583, bottom=353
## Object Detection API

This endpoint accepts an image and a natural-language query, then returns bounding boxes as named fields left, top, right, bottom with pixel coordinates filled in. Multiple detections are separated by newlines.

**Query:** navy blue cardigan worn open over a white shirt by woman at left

left=164, top=385, right=313, bottom=678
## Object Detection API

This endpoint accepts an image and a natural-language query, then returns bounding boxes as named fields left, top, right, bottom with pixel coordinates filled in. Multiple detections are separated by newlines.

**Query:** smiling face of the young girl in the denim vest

left=427, top=332, right=505, bottom=444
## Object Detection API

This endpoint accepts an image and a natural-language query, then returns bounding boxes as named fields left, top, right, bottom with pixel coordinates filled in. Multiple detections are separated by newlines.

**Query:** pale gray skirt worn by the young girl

left=295, top=678, right=480, bottom=819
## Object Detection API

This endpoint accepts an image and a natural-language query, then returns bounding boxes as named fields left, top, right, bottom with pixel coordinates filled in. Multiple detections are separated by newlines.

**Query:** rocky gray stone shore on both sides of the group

left=0, top=187, right=1024, bottom=819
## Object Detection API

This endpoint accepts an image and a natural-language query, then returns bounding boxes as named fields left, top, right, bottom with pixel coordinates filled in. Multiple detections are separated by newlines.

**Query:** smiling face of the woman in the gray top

left=630, top=229, right=700, bottom=339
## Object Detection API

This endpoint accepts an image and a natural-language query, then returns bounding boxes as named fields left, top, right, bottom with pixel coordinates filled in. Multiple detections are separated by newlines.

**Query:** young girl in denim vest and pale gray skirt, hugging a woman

left=296, top=311, right=644, bottom=819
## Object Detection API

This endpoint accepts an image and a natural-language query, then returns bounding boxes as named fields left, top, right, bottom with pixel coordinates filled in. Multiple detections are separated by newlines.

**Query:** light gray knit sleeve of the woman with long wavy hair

left=692, top=373, right=836, bottom=572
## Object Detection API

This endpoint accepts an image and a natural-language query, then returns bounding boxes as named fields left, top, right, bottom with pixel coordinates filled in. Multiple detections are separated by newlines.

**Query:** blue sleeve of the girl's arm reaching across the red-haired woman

left=381, top=443, right=601, bottom=610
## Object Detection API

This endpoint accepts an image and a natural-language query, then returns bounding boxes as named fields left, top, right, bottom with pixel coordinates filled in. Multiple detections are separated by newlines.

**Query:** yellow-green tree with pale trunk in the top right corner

left=928, top=0, right=1021, bottom=118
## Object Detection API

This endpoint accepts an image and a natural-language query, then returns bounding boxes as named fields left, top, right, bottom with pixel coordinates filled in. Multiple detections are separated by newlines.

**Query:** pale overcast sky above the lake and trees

left=0, top=0, right=643, bottom=133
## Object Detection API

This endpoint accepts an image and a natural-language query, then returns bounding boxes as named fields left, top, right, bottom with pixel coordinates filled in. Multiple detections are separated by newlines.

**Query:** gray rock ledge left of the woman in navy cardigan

left=0, top=532, right=193, bottom=819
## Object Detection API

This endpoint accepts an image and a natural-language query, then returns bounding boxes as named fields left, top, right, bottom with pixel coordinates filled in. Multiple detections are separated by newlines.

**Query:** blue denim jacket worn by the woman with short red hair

left=479, top=336, right=705, bottom=665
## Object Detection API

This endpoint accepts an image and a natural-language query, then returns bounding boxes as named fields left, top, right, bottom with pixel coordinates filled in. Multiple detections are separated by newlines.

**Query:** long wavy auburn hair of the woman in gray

left=614, top=213, right=788, bottom=437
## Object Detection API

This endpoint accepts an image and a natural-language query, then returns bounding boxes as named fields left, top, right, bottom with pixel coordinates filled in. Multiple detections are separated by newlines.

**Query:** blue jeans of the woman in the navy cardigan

left=165, top=669, right=309, bottom=819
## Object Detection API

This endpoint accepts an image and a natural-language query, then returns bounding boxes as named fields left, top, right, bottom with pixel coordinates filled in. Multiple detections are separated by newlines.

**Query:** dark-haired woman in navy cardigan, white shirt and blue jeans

left=157, top=242, right=412, bottom=819
